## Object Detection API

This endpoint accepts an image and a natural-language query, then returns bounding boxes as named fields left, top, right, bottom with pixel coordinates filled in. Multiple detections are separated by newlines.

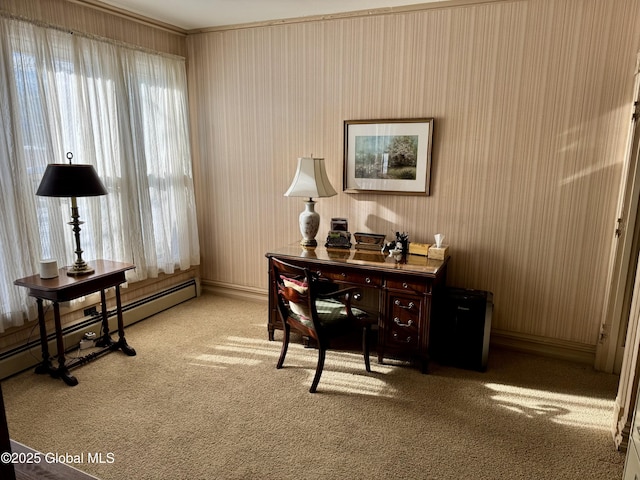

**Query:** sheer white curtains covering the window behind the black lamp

left=0, top=17, right=200, bottom=332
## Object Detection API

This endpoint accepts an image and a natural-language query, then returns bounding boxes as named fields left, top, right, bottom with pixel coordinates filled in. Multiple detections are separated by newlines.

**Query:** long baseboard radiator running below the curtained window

left=0, top=279, right=200, bottom=380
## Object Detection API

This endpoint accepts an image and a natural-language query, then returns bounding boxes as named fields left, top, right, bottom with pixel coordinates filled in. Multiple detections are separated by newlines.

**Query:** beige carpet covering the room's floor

left=3, top=293, right=624, bottom=480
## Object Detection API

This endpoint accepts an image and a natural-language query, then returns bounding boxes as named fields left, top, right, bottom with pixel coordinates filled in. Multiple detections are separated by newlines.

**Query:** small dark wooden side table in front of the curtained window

left=14, top=260, right=136, bottom=386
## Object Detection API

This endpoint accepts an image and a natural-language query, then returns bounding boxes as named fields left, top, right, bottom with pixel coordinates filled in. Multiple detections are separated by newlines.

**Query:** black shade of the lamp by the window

left=36, top=163, right=107, bottom=197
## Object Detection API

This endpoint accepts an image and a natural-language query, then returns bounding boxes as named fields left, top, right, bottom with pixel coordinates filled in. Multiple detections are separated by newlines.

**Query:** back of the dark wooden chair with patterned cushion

left=271, top=258, right=321, bottom=340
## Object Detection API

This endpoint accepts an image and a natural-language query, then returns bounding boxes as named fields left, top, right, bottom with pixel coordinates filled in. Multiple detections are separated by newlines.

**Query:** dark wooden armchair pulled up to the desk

left=271, top=258, right=375, bottom=393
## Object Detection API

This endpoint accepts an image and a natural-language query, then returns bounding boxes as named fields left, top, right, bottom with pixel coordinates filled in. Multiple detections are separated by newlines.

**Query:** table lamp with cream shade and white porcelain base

left=284, top=156, right=337, bottom=248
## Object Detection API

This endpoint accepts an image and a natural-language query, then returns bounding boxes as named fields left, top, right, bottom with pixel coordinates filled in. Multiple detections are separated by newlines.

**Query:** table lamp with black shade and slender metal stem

left=36, top=153, right=107, bottom=277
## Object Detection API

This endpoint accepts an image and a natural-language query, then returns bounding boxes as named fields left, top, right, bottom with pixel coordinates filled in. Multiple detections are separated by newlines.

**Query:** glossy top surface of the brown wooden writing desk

left=266, top=243, right=449, bottom=276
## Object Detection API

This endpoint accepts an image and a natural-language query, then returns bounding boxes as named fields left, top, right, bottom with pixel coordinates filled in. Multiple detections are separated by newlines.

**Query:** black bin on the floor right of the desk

left=429, top=288, right=493, bottom=371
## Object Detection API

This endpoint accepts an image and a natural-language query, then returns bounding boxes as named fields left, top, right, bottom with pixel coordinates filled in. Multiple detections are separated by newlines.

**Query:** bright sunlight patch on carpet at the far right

left=485, top=383, right=612, bottom=431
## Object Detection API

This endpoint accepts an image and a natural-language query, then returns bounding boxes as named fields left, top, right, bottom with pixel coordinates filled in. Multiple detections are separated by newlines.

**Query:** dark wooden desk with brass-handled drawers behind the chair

left=266, top=243, right=449, bottom=373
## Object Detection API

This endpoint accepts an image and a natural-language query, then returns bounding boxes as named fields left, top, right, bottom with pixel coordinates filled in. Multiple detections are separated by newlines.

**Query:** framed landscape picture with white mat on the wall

left=342, top=118, right=433, bottom=196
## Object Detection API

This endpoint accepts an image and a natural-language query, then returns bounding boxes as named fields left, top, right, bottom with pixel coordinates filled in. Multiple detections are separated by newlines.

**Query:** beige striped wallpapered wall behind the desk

left=187, top=0, right=640, bottom=353
